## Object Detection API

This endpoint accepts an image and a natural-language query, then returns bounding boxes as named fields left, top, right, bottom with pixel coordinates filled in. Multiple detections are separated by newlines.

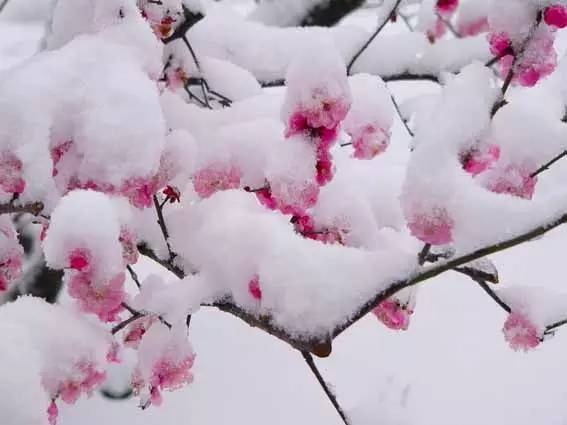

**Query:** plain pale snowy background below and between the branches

left=5, top=0, right=567, bottom=425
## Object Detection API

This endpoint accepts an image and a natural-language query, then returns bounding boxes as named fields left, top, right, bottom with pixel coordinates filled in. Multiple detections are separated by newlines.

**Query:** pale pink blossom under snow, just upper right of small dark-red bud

left=193, top=163, right=241, bottom=198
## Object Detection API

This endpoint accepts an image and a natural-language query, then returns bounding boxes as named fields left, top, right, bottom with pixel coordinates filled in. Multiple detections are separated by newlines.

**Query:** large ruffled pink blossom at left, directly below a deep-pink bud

left=69, top=271, right=126, bottom=322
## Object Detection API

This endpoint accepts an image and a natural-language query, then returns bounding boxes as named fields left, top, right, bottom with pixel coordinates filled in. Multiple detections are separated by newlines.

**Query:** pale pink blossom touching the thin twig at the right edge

left=485, top=164, right=537, bottom=199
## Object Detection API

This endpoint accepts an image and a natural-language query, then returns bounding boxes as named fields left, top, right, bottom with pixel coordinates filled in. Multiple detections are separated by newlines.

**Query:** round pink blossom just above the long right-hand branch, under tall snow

left=408, top=207, right=453, bottom=245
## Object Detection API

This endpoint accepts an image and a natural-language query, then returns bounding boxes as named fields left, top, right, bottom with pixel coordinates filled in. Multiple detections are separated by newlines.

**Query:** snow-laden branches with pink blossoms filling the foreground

left=0, top=0, right=567, bottom=425
